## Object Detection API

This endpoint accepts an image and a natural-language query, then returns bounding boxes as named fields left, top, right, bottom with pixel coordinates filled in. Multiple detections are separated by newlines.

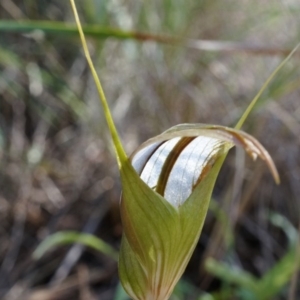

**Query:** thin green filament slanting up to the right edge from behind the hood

left=235, top=43, right=300, bottom=129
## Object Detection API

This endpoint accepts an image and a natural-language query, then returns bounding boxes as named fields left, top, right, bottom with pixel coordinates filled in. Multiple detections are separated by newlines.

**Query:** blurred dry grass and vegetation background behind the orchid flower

left=0, top=0, right=300, bottom=300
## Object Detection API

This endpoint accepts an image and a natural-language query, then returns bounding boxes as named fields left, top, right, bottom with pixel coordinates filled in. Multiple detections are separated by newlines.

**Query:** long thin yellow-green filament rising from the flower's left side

left=70, top=0, right=127, bottom=168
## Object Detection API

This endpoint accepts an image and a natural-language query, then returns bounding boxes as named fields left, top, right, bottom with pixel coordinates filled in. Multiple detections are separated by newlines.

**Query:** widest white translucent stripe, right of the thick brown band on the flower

left=164, top=136, right=222, bottom=206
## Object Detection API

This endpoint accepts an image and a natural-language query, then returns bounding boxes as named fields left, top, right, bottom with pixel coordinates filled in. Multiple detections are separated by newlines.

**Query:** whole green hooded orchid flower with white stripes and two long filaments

left=70, top=0, right=298, bottom=300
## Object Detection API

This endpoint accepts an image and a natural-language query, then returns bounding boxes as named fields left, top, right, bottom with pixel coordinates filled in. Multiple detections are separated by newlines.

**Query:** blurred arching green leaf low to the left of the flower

left=33, top=231, right=118, bottom=260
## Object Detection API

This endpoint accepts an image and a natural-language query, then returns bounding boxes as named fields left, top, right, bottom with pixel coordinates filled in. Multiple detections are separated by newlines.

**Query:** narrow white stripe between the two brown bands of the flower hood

left=141, top=137, right=181, bottom=188
